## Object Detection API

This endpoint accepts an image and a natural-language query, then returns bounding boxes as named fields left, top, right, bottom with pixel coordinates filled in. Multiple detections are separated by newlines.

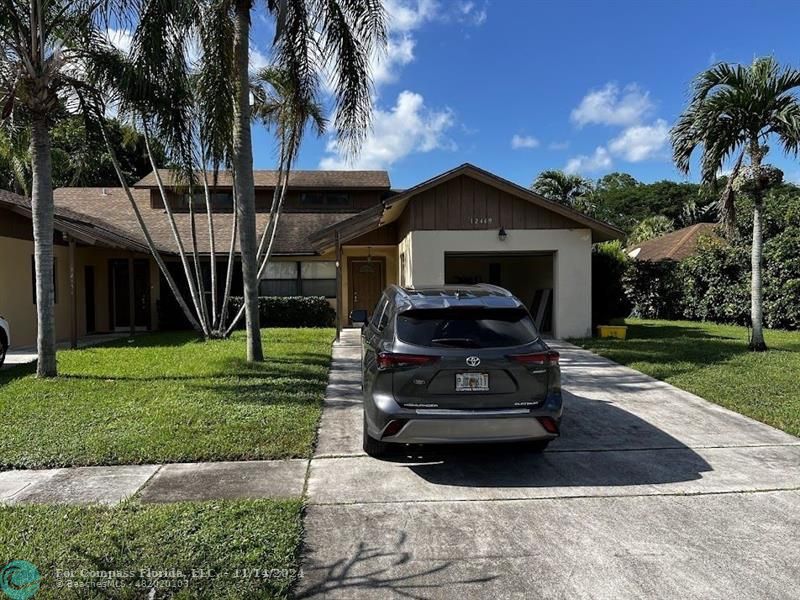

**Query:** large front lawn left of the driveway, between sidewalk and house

left=0, top=329, right=334, bottom=469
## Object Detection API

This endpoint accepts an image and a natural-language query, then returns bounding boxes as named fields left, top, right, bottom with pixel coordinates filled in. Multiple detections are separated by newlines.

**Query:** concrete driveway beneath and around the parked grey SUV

left=296, top=331, right=800, bottom=599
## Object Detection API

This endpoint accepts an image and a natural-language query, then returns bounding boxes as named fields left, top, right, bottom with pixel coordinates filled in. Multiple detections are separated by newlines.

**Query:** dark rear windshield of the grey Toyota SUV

left=397, top=308, right=539, bottom=348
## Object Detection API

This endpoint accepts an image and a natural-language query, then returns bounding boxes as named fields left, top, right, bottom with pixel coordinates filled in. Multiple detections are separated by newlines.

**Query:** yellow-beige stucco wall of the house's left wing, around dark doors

left=0, top=237, right=159, bottom=347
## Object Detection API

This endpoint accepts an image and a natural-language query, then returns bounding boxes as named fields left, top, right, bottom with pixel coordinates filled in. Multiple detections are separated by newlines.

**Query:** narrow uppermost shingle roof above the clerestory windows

left=134, top=169, right=390, bottom=190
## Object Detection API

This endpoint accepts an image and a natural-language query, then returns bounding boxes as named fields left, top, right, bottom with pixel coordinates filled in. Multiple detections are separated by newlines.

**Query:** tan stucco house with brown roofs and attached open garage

left=0, top=164, right=622, bottom=345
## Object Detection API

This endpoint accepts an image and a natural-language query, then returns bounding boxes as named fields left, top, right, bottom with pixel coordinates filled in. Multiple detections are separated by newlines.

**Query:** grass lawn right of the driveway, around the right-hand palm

left=571, top=319, right=800, bottom=436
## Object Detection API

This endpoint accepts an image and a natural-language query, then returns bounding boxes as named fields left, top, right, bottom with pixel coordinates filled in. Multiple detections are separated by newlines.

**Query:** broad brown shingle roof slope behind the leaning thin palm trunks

left=53, top=188, right=355, bottom=254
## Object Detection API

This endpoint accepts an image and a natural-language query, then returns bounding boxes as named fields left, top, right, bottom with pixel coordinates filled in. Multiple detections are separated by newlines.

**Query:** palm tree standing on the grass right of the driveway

left=671, top=57, right=800, bottom=351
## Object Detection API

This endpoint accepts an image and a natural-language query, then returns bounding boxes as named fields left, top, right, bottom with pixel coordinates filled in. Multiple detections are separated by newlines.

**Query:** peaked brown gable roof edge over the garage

left=311, top=163, right=624, bottom=250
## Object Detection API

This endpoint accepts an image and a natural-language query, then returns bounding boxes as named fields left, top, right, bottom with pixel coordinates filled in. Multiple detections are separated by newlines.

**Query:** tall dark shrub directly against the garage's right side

left=592, top=241, right=631, bottom=328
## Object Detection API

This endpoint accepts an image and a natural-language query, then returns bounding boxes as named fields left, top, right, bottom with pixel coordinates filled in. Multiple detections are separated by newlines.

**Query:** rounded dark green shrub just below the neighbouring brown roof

left=622, top=260, right=682, bottom=319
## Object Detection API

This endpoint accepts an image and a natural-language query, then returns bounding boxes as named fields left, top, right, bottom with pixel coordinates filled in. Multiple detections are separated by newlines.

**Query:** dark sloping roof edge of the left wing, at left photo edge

left=0, top=190, right=149, bottom=252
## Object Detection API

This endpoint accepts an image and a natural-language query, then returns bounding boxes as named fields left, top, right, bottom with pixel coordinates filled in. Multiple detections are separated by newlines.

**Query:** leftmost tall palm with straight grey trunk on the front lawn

left=0, top=0, right=117, bottom=377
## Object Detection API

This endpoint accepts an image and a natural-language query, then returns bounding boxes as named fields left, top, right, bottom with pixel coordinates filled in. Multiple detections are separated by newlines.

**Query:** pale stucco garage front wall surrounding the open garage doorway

left=400, top=229, right=592, bottom=338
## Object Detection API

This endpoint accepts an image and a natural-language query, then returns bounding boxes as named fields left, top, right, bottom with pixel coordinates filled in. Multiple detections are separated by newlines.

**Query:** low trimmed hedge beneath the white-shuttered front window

left=228, top=296, right=336, bottom=329
